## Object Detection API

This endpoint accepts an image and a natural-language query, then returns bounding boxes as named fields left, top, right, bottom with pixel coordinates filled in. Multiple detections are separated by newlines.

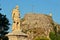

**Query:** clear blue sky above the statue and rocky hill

left=0, top=0, right=60, bottom=31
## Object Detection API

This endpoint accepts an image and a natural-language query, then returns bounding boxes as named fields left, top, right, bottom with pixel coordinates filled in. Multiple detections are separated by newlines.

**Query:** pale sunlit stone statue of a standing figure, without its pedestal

left=12, top=6, right=20, bottom=31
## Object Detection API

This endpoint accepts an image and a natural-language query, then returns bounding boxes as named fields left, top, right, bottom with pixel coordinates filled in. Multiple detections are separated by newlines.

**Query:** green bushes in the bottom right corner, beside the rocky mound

left=49, top=24, right=60, bottom=40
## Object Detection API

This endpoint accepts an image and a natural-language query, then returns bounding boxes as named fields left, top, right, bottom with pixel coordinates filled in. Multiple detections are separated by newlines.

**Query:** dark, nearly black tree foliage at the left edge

left=0, top=13, right=10, bottom=39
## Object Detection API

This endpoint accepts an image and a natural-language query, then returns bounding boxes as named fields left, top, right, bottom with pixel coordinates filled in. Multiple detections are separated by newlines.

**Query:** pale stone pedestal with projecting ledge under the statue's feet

left=7, top=31, right=28, bottom=40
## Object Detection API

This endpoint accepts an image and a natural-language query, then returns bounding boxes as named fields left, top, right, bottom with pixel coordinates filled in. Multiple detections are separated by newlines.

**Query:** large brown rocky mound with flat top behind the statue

left=21, top=13, right=53, bottom=39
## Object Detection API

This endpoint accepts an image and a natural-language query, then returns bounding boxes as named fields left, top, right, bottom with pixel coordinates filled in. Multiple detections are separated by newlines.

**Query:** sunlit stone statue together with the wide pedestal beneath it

left=6, top=6, right=28, bottom=40
